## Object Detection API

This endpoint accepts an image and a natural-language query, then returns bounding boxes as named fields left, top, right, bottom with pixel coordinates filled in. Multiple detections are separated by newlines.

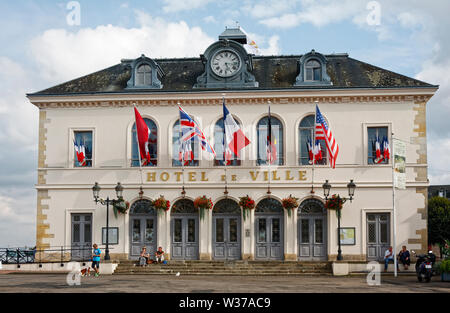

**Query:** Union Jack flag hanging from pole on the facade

left=178, top=106, right=216, bottom=162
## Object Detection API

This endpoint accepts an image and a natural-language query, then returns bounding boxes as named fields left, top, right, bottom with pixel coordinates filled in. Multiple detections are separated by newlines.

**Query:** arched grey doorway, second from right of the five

left=255, top=198, right=284, bottom=260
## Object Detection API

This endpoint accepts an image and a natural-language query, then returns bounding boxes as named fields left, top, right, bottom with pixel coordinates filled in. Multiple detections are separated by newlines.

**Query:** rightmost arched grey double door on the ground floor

left=297, top=199, right=327, bottom=261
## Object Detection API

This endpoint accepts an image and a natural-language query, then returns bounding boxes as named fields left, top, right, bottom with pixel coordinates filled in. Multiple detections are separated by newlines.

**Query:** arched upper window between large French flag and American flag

left=256, top=116, right=284, bottom=165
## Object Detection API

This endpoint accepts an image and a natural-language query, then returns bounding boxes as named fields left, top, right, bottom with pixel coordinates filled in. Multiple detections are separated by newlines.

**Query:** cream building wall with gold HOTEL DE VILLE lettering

left=31, top=91, right=430, bottom=259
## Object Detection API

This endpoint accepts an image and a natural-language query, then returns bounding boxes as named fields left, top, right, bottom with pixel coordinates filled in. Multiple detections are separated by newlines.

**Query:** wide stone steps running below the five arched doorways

left=114, top=260, right=332, bottom=276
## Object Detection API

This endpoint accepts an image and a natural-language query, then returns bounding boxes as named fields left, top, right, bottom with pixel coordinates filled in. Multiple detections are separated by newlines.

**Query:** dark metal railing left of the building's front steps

left=0, top=244, right=111, bottom=266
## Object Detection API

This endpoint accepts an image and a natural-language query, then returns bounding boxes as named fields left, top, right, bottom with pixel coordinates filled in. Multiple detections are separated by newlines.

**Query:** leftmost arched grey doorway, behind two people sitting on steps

left=130, top=199, right=157, bottom=259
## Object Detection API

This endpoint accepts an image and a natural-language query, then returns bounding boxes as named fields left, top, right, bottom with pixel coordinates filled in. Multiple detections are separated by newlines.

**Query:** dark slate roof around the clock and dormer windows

left=29, top=54, right=437, bottom=96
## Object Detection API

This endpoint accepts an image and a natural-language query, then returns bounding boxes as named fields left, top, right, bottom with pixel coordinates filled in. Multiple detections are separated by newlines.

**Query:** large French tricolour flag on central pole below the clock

left=223, top=99, right=250, bottom=162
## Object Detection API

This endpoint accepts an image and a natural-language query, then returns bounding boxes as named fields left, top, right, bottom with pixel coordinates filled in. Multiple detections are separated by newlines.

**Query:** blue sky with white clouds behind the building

left=0, top=0, right=450, bottom=247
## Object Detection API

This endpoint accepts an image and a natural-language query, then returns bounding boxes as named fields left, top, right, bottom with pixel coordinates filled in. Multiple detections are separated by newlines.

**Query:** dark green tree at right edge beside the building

left=428, top=197, right=450, bottom=247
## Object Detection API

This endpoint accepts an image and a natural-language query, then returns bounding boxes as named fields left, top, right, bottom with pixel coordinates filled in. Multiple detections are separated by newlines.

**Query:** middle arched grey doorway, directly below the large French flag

left=212, top=199, right=241, bottom=260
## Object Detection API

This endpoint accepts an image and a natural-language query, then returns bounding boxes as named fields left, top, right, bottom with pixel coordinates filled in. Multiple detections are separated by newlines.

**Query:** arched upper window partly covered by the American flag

left=298, top=115, right=327, bottom=165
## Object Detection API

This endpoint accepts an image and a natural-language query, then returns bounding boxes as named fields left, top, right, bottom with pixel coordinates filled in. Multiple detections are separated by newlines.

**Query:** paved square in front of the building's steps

left=0, top=273, right=450, bottom=293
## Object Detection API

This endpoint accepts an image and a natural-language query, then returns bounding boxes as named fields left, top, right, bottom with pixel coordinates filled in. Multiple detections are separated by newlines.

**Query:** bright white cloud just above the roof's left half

left=31, top=11, right=214, bottom=82
